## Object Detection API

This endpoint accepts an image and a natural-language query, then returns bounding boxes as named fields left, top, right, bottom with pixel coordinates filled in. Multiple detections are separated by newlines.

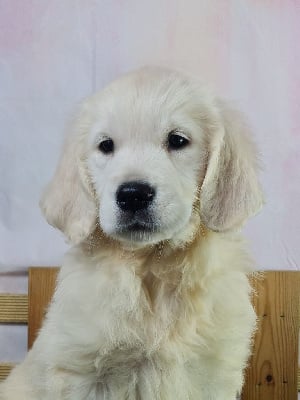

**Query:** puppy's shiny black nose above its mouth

left=116, top=182, right=155, bottom=212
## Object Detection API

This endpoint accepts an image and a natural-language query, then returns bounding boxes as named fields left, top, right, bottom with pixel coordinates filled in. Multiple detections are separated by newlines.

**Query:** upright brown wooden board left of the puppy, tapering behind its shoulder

left=28, top=268, right=58, bottom=349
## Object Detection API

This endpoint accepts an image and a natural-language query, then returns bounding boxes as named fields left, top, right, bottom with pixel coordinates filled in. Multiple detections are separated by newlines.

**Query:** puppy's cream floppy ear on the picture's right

left=200, top=100, right=263, bottom=231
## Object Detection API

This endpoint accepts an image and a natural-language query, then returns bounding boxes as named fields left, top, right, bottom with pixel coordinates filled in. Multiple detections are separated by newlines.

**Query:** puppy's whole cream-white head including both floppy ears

left=41, top=68, right=262, bottom=246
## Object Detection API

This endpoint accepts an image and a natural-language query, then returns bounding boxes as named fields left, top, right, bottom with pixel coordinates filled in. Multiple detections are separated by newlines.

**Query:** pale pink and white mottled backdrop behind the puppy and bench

left=0, top=0, right=300, bottom=360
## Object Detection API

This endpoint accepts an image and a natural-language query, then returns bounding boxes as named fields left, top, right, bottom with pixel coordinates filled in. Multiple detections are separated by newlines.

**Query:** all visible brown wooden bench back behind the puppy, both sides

left=0, top=268, right=300, bottom=400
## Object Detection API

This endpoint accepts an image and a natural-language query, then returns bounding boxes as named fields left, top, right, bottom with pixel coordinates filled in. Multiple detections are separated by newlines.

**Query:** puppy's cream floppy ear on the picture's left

left=40, top=109, right=97, bottom=244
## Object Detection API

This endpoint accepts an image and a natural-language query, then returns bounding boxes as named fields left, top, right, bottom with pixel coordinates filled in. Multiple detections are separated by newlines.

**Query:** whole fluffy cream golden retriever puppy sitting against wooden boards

left=0, top=68, right=262, bottom=400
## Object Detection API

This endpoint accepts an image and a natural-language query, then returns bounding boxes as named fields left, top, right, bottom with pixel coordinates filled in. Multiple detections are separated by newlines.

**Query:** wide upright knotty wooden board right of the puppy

left=242, top=271, right=300, bottom=400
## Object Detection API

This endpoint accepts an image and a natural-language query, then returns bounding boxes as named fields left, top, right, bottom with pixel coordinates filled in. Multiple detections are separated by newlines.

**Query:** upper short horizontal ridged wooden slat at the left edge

left=0, top=293, right=28, bottom=324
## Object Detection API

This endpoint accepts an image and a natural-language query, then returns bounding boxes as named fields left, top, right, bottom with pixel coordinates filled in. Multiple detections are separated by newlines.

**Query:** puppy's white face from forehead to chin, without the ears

left=87, top=70, right=207, bottom=245
